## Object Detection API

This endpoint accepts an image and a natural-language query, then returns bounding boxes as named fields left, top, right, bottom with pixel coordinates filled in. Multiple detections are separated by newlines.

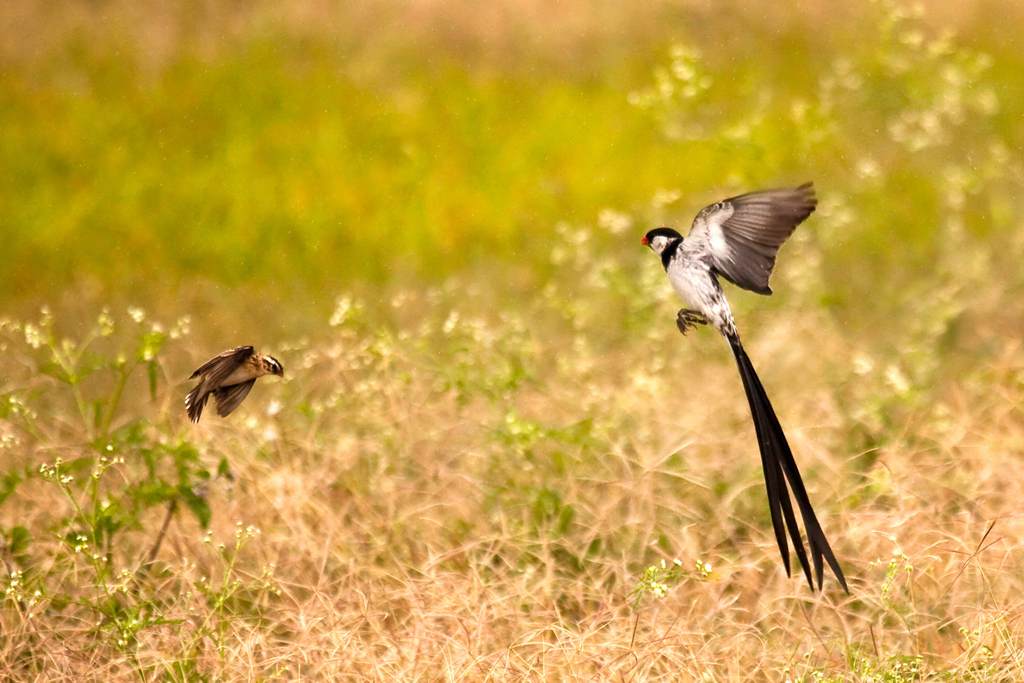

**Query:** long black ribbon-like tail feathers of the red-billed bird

left=729, top=336, right=850, bottom=593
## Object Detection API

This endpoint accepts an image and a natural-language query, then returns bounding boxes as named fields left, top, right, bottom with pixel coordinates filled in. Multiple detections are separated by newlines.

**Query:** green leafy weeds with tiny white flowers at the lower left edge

left=0, top=308, right=276, bottom=674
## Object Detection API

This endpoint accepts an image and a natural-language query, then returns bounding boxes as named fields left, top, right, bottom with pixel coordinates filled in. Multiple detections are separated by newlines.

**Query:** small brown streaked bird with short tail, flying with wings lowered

left=185, top=346, right=285, bottom=422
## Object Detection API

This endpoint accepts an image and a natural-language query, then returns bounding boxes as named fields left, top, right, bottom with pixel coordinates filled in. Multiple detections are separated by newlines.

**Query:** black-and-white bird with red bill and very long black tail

left=642, top=182, right=850, bottom=593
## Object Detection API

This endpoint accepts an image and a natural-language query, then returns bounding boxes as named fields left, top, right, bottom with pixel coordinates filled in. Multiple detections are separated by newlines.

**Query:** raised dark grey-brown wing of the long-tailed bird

left=686, top=182, right=818, bottom=294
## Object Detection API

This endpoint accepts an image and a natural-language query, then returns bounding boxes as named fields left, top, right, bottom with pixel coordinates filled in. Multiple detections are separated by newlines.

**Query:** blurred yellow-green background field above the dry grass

left=0, top=1, right=1024, bottom=348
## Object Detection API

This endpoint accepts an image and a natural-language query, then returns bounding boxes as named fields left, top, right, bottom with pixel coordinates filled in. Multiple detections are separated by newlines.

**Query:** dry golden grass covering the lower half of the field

left=0, top=266, right=1024, bottom=681
